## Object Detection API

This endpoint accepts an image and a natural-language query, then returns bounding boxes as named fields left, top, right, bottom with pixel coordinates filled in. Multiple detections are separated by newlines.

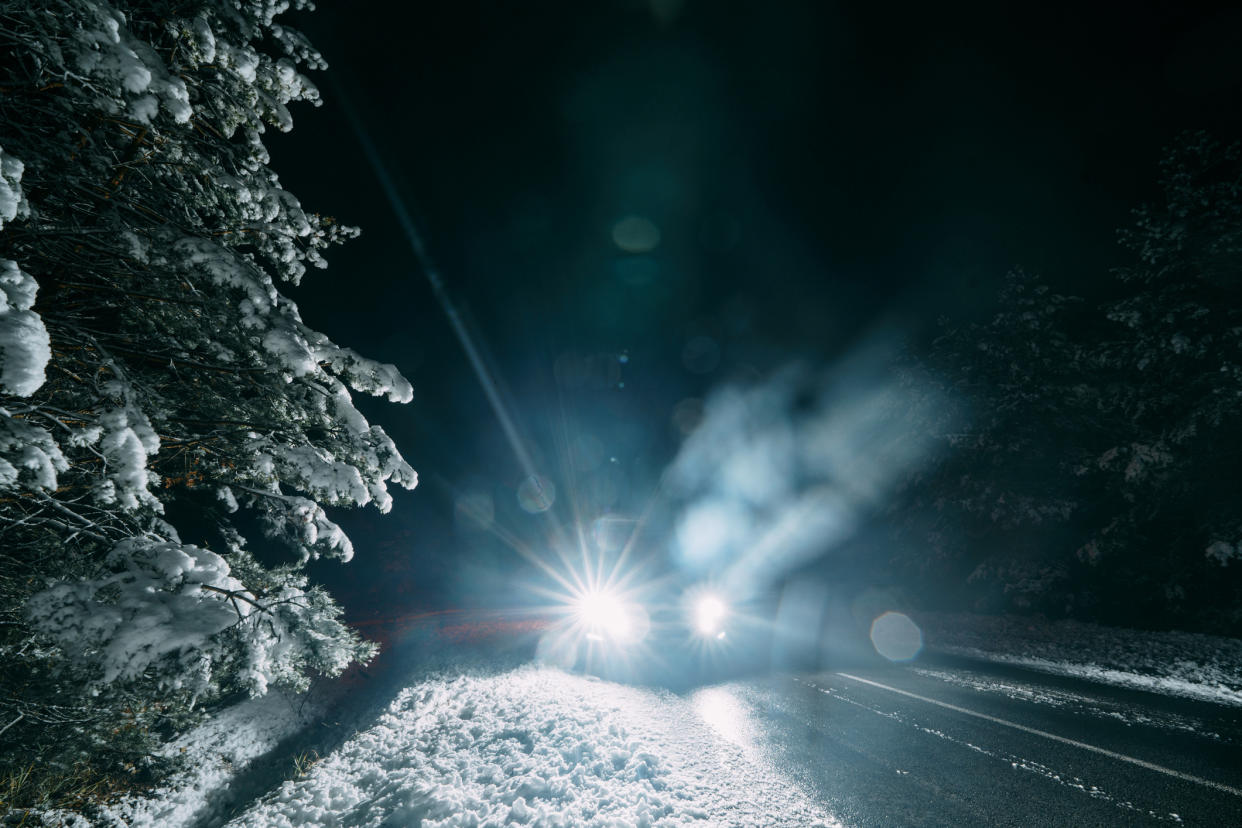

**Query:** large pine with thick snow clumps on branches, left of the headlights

left=0, top=0, right=416, bottom=804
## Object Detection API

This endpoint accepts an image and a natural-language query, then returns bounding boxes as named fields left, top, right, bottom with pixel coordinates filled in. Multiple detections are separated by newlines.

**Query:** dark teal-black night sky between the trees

left=268, top=0, right=1242, bottom=617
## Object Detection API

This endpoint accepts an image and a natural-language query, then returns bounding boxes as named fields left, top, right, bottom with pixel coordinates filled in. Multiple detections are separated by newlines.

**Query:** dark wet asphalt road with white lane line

left=715, top=659, right=1242, bottom=826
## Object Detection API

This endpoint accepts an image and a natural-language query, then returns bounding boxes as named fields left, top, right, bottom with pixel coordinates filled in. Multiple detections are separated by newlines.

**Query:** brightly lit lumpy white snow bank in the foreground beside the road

left=230, top=667, right=838, bottom=828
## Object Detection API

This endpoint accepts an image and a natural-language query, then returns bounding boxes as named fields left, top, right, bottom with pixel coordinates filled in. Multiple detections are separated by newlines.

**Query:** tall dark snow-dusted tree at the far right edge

left=1079, top=132, right=1242, bottom=626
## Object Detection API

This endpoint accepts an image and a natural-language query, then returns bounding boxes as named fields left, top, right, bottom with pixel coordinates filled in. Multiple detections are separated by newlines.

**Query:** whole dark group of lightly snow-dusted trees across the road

left=895, top=133, right=1242, bottom=631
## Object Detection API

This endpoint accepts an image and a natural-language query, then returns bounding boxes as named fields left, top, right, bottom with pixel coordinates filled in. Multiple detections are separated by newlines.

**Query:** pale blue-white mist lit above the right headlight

left=666, top=336, right=946, bottom=596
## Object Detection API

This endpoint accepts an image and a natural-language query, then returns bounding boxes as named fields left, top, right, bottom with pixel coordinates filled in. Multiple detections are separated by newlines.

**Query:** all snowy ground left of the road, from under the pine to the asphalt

left=29, top=622, right=840, bottom=828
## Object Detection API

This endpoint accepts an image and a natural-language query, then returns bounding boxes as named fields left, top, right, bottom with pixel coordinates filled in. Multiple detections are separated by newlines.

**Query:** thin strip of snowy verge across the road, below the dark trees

left=913, top=612, right=1242, bottom=705
